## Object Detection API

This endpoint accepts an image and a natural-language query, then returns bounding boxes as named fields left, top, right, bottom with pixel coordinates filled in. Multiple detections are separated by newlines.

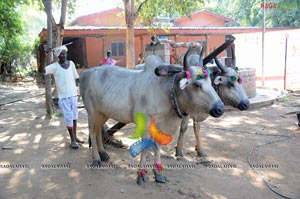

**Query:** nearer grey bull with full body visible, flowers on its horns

left=80, top=47, right=224, bottom=184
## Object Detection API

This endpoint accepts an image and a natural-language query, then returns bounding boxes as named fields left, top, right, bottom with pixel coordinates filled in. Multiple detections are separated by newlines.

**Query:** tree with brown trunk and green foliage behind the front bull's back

left=123, top=0, right=204, bottom=68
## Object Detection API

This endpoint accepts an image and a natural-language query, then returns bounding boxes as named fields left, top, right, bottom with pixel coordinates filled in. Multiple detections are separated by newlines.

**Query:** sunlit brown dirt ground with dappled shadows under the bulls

left=0, top=83, right=300, bottom=199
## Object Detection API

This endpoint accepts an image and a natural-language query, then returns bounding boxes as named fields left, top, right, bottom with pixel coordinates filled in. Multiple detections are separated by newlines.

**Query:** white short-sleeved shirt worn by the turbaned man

left=45, top=61, right=79, bottom=98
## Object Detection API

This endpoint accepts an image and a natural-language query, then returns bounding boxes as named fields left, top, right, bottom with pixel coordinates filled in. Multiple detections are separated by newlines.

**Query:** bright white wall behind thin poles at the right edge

left=234, top=29, right=300, bottom=89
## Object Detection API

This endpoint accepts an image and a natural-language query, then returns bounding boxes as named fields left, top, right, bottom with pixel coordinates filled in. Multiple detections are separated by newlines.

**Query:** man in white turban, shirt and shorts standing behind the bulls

left=45, top=45, right=84, bottom=149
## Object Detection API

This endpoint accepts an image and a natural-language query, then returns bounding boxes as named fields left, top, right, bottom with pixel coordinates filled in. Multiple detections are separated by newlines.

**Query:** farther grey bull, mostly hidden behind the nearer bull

left=176, top=48, right=250, bottom=157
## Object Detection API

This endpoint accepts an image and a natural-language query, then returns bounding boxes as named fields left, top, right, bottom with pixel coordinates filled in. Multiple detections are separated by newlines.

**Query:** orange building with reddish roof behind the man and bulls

left=40, top=8, right=238, bottom=67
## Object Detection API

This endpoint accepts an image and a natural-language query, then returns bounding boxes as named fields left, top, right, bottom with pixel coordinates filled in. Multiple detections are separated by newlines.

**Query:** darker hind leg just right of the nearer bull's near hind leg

left=96, top=115, right=109, bottom=161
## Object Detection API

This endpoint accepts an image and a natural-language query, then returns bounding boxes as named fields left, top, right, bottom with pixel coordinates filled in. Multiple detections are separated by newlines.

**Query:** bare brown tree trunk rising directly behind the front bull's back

left=123, top=0, right=136, bottom=68
